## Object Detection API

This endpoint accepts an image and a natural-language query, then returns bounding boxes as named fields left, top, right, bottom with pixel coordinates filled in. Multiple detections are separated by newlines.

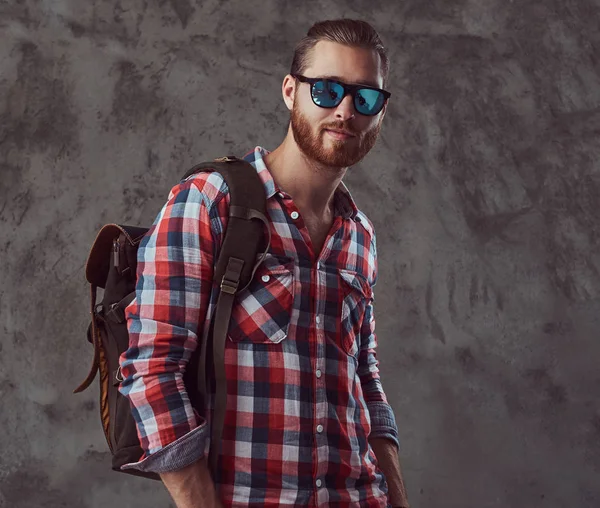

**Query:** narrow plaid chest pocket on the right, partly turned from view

left=339, top=270, right=373, bottom=356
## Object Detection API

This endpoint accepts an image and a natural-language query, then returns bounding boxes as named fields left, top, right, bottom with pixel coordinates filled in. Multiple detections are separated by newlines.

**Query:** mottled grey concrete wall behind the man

left=0, top=0, right=600, bottom=508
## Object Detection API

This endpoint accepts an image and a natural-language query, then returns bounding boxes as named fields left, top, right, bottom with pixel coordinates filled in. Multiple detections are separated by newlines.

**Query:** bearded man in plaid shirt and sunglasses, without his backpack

left=121, top=20, right=408, bottom=508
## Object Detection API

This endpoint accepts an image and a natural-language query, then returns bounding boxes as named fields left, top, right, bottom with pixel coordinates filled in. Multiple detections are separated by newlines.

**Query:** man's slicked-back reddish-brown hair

left=290, top=19, right=390, bottom=87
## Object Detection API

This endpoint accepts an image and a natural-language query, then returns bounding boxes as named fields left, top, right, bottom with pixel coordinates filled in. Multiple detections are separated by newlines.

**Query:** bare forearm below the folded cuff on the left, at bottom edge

left=160, top=459, right=222, bottom=508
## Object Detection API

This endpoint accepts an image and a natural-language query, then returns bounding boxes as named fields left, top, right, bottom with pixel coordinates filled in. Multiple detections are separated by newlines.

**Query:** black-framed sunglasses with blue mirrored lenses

left=292, top=74, right=392, bottom=116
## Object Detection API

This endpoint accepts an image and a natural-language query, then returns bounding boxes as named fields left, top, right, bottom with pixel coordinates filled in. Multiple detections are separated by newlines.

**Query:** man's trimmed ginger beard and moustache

left=291, top=102, right=381, bottom=168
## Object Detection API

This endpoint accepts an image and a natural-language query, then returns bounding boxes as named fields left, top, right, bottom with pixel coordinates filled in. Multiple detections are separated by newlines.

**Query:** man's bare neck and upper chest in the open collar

left=265, top=127, right=348, bottom=217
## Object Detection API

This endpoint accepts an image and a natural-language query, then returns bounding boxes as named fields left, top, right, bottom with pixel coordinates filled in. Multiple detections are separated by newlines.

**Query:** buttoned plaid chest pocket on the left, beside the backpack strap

left=229, top=258, right=294, bottom=344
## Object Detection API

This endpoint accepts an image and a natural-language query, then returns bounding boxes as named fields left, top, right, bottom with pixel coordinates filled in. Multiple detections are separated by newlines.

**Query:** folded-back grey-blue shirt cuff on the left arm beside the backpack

left=121, top=422, right=210, bottom=474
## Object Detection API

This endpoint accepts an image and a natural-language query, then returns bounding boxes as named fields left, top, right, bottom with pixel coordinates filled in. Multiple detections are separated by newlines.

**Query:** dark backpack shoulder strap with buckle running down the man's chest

left=183, top=157, right=270, bottom=479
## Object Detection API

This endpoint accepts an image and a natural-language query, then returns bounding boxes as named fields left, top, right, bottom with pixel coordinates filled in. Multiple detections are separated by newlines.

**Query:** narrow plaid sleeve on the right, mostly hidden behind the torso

left=358, top=235, right=400, bottom=447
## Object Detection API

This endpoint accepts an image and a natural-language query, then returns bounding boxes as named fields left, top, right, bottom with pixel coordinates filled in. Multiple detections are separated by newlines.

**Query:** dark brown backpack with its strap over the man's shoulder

left=74, top=157, right=270, bottom=480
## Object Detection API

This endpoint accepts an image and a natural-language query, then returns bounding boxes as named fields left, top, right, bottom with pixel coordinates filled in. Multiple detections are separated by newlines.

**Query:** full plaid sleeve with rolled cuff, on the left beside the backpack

left=119, top=173, right=226, bottom=473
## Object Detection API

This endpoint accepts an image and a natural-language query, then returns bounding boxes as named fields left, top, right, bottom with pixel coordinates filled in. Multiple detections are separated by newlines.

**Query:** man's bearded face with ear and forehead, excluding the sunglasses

left=283, top=41, right=385, bottom=168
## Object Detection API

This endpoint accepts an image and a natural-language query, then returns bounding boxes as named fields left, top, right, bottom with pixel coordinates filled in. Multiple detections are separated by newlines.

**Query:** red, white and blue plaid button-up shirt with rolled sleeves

left=120, top=147, right=398, bottom=507
